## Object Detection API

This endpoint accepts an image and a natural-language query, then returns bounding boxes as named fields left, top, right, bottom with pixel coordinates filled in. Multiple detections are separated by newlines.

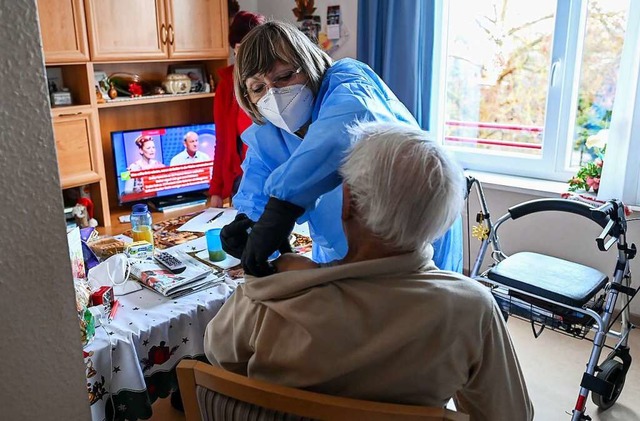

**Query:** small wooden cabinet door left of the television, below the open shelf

left=53, top=108, right=104, bottom=188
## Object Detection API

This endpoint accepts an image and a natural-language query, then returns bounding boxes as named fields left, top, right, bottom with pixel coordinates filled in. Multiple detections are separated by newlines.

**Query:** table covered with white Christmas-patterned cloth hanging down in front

left=84, top=236, right=237, bottom=421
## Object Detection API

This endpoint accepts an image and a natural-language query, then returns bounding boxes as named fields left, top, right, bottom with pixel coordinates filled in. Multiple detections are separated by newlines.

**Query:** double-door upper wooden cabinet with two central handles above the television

left=85, top=0, right=228, bottom=61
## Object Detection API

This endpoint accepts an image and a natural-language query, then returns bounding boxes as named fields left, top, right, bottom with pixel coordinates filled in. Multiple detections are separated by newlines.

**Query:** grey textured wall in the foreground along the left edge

left=0, top=0, right=90, bottom=420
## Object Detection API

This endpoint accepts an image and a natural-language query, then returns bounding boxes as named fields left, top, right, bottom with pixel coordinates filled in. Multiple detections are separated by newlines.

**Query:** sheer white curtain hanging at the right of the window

left=598, top=1, right=640, bottom=205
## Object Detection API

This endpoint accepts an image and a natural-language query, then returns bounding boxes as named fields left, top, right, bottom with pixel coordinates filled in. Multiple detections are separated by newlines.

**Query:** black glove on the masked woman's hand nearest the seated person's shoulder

left=242, top=197, right=304, bottom=276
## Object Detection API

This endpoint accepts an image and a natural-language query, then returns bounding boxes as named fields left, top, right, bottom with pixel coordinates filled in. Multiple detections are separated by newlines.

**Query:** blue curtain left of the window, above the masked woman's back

left=357, top=0, right=434, bottom=130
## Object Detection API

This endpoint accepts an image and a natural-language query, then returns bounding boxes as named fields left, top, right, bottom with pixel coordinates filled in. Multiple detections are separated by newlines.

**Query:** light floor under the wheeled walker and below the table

left=151, top=318, right=640, bottom=421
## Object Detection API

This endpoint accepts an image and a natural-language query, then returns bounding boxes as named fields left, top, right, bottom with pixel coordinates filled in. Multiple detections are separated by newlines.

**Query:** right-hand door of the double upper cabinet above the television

left=165, top=0, right=229, bottom=59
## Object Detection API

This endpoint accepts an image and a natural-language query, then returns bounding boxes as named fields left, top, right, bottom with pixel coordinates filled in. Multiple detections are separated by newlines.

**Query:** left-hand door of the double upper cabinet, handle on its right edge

left=85, top=0, right=168, bottom=61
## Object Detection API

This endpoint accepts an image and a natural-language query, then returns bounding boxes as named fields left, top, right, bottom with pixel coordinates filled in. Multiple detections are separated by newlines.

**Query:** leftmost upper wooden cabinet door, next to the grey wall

left=38, top=0, right=89, bottom=64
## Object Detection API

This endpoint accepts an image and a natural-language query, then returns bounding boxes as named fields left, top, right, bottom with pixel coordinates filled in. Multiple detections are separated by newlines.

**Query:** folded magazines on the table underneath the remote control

left=131, top=253, right=224, bottom=298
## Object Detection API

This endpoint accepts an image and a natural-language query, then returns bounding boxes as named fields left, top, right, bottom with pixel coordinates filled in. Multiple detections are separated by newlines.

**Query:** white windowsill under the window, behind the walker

left=465, top=170, right=569, bottom=197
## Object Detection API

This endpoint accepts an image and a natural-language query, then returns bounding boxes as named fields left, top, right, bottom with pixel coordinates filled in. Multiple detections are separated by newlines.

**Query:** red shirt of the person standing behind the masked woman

left=209, top=65, right=253, bottom=199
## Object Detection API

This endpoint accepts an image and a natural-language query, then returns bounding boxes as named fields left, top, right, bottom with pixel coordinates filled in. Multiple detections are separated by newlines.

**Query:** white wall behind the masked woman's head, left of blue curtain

left=251, top=0, right=358, bottom=60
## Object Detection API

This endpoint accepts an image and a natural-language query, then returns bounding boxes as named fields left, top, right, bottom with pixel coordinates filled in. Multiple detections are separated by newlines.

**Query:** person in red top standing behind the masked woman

left=209, top=11, right=266, bottom=208
